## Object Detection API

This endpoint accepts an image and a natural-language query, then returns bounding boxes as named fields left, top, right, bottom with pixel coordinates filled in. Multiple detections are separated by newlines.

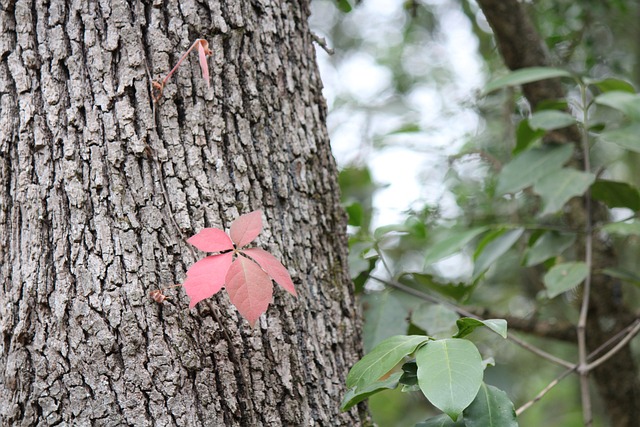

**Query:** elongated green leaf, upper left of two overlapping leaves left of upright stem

left=496, top=144, right=573, bottom=195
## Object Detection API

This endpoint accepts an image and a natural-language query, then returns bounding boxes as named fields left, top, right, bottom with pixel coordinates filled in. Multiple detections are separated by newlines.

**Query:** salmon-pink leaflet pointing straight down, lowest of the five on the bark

left=226, top=256, right=273, bottom=327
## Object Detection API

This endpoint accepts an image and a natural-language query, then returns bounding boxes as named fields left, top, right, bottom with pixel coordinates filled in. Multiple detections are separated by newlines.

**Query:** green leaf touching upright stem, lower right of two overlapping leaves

left=533, top=168, right=596, bottom=216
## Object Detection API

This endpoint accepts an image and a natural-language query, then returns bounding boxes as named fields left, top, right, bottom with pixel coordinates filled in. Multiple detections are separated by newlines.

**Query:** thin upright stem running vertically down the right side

left=577, top=84, right=593, bottom=427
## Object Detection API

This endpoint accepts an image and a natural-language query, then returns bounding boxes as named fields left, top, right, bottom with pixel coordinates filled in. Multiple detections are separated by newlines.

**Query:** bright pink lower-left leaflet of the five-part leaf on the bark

left=182, top=252, right=233, bottom=308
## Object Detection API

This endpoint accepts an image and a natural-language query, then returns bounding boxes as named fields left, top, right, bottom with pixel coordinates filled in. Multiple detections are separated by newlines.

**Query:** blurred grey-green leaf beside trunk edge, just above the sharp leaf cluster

left=362, top=291, right=408, bottom=353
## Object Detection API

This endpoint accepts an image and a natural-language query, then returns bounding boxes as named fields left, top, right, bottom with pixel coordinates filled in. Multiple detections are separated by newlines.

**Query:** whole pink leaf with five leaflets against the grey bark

left=183, top=211, right=296, bottom=326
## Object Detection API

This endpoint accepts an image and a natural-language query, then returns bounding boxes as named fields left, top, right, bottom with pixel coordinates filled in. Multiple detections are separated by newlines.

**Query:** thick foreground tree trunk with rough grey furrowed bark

left=0, top=0, right=366, bottom=426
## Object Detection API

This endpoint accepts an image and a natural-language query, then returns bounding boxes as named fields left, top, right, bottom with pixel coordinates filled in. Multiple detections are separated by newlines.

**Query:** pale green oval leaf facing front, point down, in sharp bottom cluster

left=416, top=338, right=483, bottom=421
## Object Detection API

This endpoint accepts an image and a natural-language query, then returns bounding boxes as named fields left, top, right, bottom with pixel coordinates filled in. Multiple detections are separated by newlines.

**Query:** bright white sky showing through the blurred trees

left=311, top=0, right=485, bottom=226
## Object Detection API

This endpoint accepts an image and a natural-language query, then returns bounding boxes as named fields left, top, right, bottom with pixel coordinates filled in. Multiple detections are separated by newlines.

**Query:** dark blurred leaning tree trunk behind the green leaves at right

left=478, top=0, right=640, bottom=427
